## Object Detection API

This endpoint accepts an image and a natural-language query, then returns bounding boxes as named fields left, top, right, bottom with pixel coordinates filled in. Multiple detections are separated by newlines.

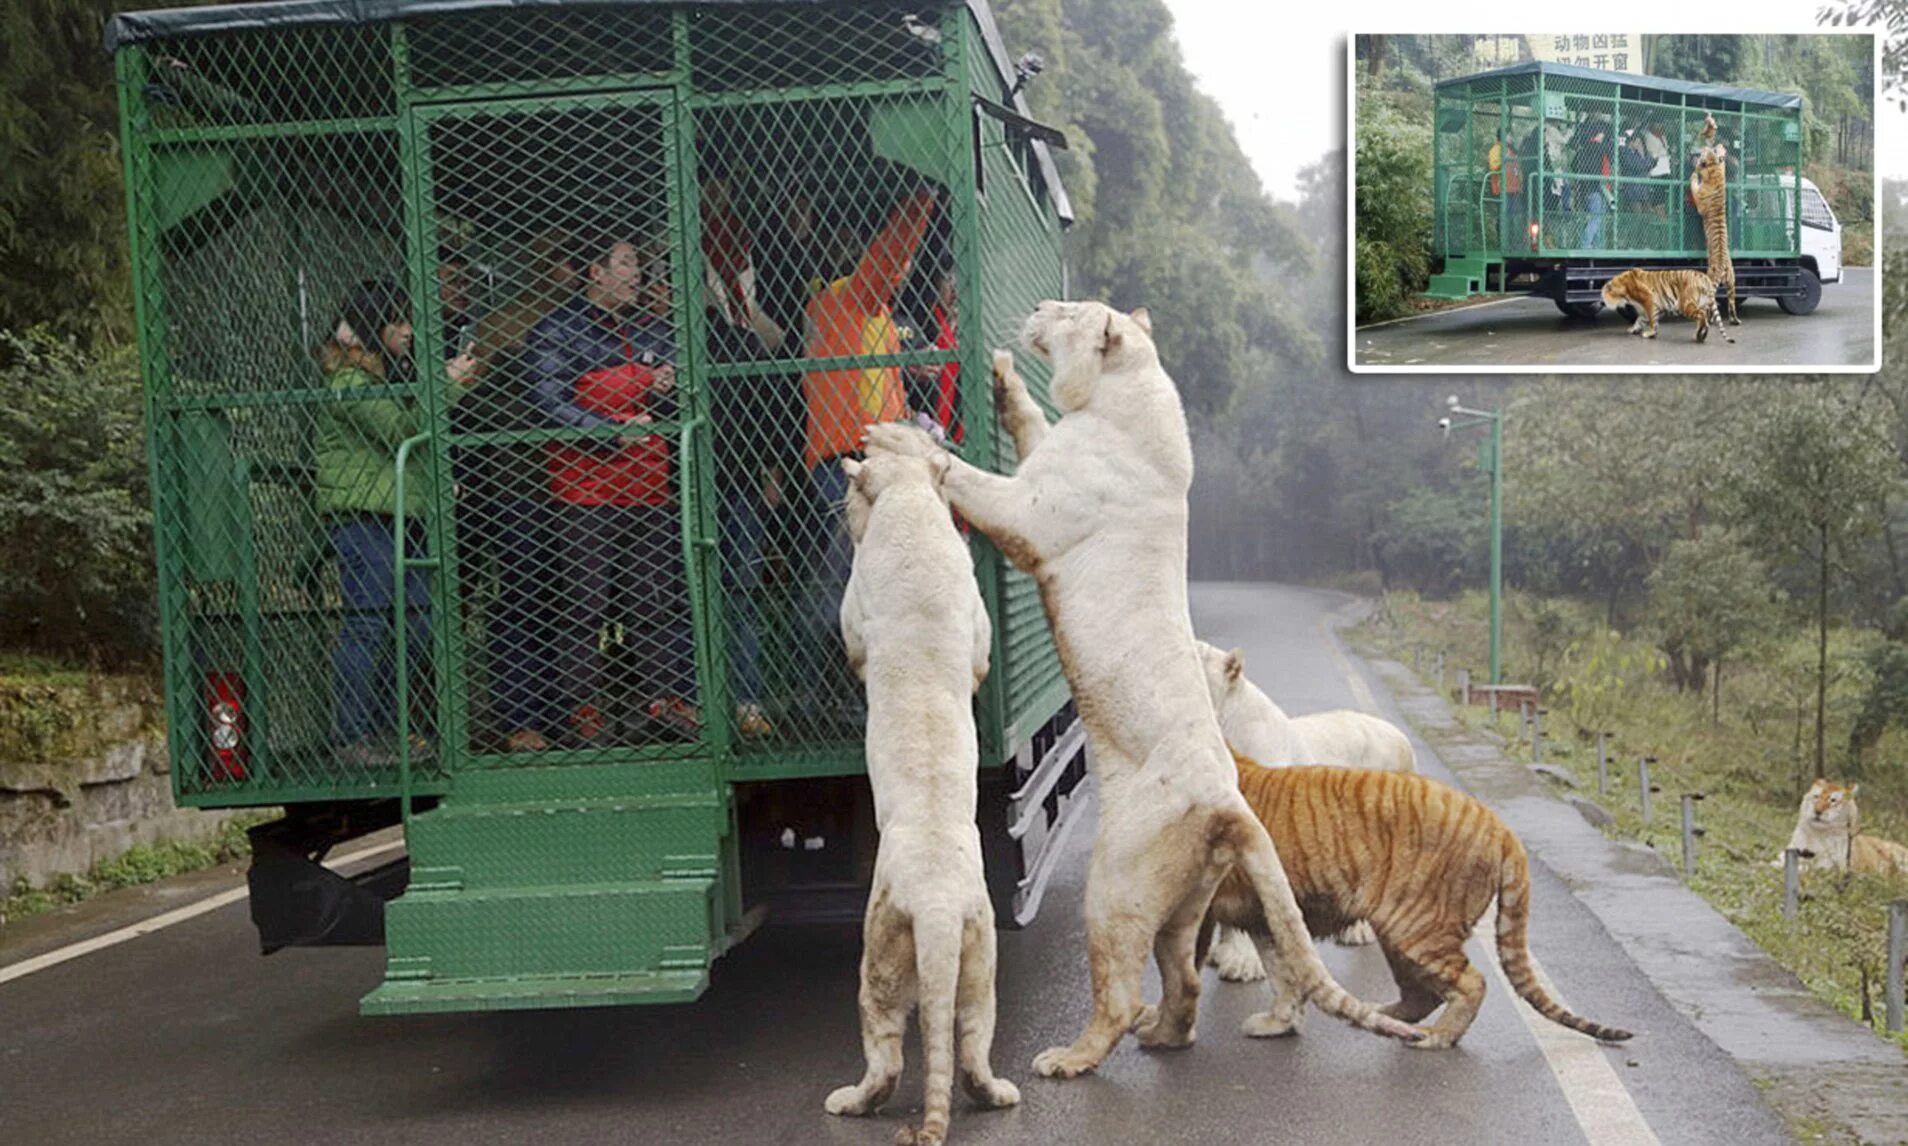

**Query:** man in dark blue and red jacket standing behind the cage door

left=525, top=231, right=700, bottom=744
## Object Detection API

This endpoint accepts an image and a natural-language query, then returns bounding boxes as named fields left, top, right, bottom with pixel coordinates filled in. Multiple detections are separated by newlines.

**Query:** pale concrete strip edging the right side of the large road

left=1334, top=614, right=1908, bottom=1142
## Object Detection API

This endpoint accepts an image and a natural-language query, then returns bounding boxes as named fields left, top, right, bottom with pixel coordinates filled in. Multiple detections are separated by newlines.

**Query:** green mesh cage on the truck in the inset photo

left=1433, top=65, right=1801, bottom=261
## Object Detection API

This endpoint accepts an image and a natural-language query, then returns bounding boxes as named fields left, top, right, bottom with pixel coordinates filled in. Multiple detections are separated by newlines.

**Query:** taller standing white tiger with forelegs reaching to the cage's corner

left=868, top=301, right=1423, bottom=1077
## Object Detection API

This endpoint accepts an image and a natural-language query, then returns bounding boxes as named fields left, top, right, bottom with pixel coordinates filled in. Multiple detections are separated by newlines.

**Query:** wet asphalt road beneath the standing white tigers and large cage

left=0, top=585, right=1788, bottom=1146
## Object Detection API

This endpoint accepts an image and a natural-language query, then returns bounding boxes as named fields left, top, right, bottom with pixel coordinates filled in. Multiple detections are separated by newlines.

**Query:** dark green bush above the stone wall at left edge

left=0, top=328, right=156, bottom=667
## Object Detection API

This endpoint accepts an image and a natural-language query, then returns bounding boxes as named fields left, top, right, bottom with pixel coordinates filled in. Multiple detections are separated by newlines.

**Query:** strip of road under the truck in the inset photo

left=1353, top=267, right=1876, bottom=370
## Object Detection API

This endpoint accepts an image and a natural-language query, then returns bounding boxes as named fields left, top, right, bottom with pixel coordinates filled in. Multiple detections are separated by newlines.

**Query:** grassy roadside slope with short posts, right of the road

left=1349, top=593, right=1908, bottom=1047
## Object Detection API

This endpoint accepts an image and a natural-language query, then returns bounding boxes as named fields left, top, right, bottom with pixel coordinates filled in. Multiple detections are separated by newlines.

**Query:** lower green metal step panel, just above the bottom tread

left=385, top=879, right=719, bottom=982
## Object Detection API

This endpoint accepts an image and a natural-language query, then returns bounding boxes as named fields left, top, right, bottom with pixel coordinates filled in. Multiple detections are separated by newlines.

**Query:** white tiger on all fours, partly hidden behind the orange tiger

left=1194, top=641, right=1418, bottom=982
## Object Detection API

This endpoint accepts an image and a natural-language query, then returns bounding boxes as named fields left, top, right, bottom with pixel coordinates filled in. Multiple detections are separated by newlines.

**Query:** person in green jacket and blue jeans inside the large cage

left=315, top=278, right=477, bottom=761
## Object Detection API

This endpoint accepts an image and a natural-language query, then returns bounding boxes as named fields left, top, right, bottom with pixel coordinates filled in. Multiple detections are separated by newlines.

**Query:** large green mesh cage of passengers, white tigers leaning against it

left=116, top=4, right=1067, bottom=803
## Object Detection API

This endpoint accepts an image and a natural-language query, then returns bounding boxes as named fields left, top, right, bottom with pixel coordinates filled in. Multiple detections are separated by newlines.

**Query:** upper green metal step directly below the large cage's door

left=406, top=791, right=729, bottom=890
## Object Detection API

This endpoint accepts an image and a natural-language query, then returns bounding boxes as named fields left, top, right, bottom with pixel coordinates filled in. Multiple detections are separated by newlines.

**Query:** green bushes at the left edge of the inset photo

left=1353, top=88, right=1431, bottom=322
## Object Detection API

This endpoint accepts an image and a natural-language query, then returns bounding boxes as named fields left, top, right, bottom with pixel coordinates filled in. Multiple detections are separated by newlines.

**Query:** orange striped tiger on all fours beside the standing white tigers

left=1198, top=753, right=1629, bottom=1047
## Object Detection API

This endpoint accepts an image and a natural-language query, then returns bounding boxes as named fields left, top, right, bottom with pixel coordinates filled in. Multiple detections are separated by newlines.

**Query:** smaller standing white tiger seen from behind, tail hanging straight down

left=826, top=456, right=1021, bottom=1146
